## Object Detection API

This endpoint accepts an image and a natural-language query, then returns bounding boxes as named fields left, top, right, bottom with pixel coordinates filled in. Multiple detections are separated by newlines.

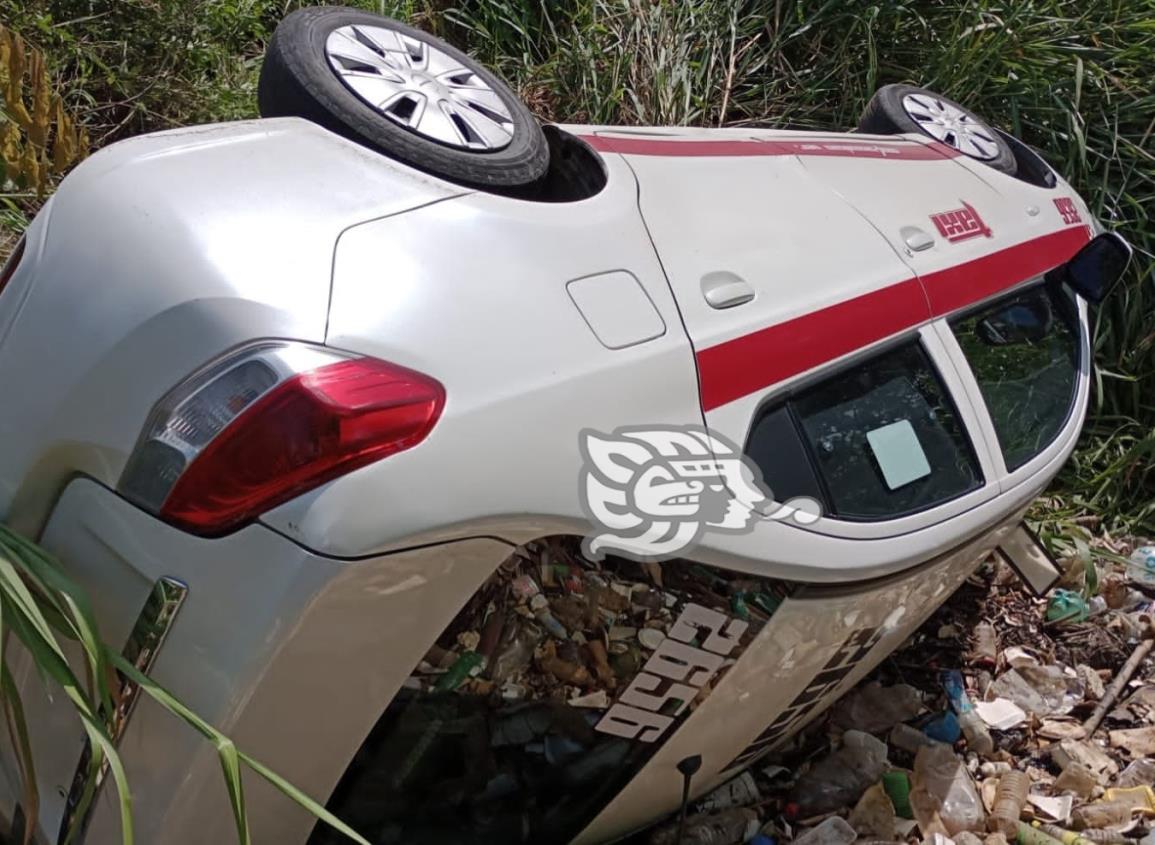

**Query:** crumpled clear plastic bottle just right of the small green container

left=910, top=745, right=985, bottom=838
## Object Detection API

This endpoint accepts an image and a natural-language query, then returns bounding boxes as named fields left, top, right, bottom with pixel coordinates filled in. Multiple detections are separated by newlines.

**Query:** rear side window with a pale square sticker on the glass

left=746, top=342, right=983, bottom=521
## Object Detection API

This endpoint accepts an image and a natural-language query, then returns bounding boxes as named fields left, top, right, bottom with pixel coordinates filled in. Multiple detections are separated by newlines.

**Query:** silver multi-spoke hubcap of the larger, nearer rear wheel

left=325, top=24, right=514, bottom=152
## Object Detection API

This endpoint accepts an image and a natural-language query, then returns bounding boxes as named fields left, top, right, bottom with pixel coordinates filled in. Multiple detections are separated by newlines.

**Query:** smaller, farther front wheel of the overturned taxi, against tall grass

left=858, top=85, right=1015, bottom=175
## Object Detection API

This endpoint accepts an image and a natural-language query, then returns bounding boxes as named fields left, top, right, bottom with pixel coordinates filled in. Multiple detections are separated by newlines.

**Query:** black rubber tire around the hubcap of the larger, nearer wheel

left=258, top=6, right=549, bottom=188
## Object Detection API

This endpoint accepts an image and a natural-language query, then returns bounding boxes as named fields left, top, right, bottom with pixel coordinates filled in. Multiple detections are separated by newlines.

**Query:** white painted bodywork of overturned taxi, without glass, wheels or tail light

left=0, top=119, right=1095, bottom=845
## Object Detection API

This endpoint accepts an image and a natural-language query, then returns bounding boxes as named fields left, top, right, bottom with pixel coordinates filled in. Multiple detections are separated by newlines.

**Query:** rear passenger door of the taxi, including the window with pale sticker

left=618, top=133, right=994, bottom=547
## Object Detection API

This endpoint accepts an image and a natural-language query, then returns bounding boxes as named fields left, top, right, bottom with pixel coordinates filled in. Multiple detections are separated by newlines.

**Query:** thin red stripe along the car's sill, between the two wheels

left=581, top=135, right=961, bottom=162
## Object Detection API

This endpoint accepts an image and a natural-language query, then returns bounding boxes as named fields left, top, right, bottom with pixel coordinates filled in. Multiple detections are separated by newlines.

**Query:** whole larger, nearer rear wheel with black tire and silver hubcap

left=258, top=7, right=549, bottom=188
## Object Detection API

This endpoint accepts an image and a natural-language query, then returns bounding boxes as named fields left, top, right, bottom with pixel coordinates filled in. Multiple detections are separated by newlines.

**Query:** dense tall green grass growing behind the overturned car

left=0, top=0, right=1155, bottom=533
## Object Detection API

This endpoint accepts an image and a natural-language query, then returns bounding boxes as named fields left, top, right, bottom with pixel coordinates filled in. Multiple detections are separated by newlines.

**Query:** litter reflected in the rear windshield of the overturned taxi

left=407, top=541, right=785, bottom=710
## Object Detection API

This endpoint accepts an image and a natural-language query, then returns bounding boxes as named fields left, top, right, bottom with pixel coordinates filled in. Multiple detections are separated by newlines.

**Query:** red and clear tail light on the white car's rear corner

left=119, top=343, right=445, bottom=536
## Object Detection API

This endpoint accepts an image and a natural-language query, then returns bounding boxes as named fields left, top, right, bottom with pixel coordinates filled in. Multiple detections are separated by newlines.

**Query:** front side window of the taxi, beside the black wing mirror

left=951, top=285, right=1079, bottom=470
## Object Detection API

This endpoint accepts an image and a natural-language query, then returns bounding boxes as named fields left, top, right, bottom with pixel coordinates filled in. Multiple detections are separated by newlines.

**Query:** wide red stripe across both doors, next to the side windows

left=696, top=226, right=1090, bottom=411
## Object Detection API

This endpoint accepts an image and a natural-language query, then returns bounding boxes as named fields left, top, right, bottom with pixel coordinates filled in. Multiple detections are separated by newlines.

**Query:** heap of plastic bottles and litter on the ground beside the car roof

left=640, top=546, right=1155, bottom=845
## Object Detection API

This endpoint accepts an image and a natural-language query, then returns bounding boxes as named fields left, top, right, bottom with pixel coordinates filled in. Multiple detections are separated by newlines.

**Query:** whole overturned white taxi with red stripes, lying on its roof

left=0, top=9, right=1127, bottom=845
